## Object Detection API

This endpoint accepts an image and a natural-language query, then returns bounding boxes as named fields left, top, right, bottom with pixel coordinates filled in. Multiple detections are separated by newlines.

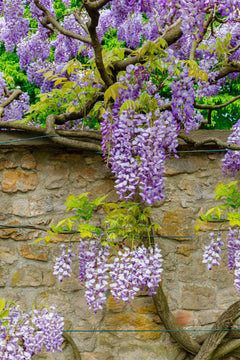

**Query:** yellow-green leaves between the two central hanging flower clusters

left=41, top=193, right=160, bottom=246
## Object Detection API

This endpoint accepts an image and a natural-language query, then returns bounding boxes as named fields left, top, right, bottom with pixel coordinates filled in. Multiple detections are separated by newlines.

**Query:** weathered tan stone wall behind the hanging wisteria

left=0, top=132, right=238, bottom=360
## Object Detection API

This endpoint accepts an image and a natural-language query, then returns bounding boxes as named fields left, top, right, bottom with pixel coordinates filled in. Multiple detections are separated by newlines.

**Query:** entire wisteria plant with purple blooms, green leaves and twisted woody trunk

left=0, top=0, right=240, bottom=360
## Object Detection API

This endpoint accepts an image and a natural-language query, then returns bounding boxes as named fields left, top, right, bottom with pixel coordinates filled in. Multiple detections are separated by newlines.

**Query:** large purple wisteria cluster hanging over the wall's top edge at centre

left=101, top=65, right=180, bottom=204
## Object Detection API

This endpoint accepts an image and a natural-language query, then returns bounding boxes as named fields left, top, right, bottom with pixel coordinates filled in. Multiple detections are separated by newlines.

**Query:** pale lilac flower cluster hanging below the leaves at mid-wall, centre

left=54, top=239, right=163, bottom=312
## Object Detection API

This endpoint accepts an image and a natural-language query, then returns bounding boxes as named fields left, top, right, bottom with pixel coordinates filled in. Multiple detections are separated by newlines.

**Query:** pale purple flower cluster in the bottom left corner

left=0, top=305, right=64, bottom=360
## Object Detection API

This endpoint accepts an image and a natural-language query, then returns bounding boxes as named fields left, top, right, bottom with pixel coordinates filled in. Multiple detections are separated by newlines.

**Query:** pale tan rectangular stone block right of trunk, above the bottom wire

left=181, top=285, right=216, bottom=310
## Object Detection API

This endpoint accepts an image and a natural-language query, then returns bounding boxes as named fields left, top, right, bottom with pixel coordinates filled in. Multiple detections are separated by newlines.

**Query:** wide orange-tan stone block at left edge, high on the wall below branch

left=2, top=170, right=39, bottom=192
